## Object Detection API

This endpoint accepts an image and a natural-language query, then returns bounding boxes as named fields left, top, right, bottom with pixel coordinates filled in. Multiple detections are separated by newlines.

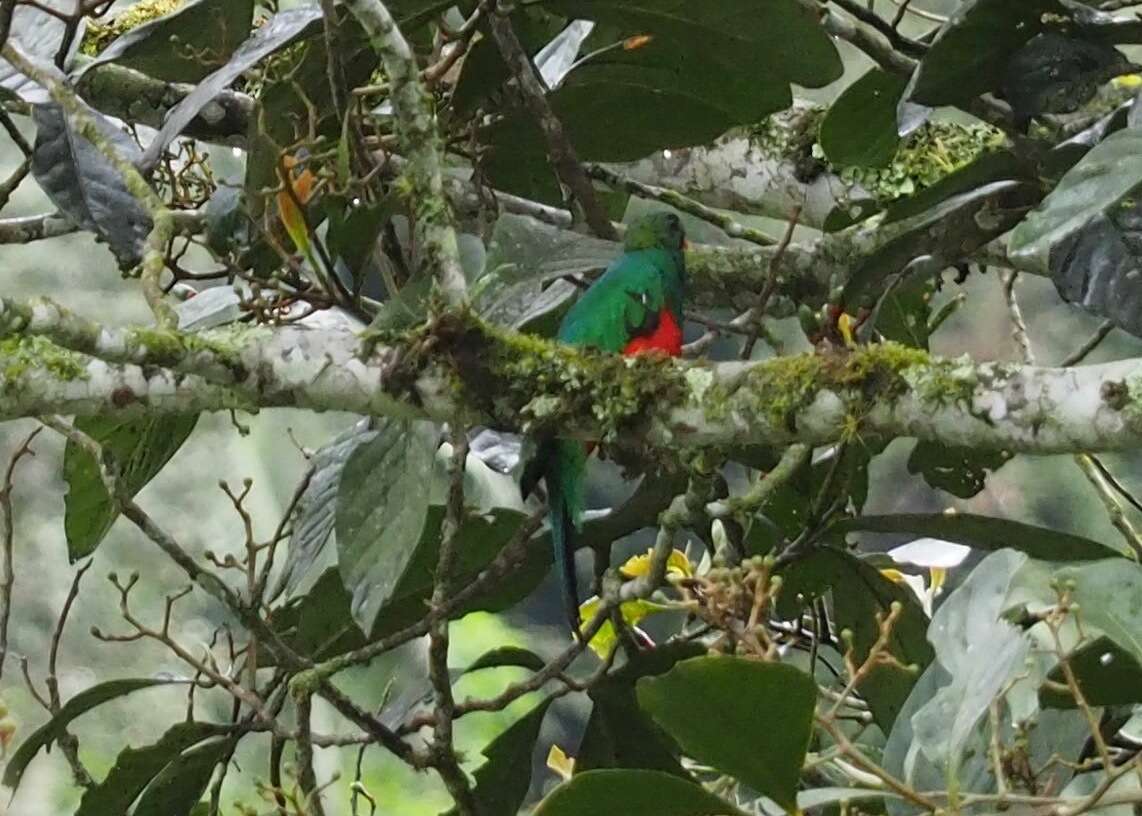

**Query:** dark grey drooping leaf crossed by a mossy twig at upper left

left=32, top=104, right=151, bottom=266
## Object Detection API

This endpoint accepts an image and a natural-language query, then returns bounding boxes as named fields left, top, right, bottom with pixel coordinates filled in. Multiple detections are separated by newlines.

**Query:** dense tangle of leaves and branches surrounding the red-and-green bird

left=0, top=0, right=1142, bottom=816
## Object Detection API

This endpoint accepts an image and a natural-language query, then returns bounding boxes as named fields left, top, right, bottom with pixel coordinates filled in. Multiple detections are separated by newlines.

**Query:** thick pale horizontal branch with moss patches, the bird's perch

left=0, top=301, right=1142, bottom=454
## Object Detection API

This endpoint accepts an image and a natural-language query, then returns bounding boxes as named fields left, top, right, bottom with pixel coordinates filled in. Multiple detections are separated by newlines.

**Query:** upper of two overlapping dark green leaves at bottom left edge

left=75, top=722, right=231, bottom=816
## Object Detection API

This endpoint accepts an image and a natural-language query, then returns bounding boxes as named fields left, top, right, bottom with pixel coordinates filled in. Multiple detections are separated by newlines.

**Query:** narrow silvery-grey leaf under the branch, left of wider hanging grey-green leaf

left=271, top=420, right=377, bottom=598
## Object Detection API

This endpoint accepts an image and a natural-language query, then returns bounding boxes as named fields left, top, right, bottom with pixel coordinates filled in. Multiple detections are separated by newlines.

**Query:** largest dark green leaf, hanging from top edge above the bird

left=485, top=0, right=843, bottom=202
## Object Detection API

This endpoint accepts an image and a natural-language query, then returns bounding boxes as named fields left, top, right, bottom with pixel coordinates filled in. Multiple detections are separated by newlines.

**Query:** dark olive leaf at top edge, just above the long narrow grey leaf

left=83, top=0, right=254, bottom=82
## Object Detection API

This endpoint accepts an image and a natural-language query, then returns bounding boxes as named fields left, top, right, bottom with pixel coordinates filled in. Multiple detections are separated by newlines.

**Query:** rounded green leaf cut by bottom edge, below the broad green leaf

left=536, top=770, right=745, bottom=816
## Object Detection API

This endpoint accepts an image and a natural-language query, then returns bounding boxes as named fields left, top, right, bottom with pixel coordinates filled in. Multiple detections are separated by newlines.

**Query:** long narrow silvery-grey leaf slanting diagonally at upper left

left=142, top=6, right=321, bottom=167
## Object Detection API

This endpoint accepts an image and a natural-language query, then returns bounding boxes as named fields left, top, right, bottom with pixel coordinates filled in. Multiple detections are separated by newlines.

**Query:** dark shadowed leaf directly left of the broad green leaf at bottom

left=574, top=643, right=705, bottom=778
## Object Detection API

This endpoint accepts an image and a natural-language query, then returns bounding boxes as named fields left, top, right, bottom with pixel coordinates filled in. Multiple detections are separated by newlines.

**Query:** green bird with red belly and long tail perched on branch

left=521, top=212, right=686, bottom=636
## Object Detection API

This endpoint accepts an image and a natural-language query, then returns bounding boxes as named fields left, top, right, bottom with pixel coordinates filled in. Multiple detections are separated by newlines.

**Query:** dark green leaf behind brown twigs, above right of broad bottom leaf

left=778, top=549, right=932, bottom=733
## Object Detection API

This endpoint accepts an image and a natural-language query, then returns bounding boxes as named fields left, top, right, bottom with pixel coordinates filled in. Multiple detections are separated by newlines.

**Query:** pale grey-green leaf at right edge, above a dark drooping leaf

left=1007, top=128, right=1142, bottom=275
